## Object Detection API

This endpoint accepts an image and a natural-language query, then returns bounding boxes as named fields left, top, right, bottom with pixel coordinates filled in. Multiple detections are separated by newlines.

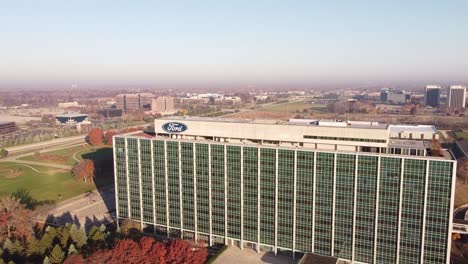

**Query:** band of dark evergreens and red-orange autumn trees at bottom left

left=0, top=195, right=208, bottom=264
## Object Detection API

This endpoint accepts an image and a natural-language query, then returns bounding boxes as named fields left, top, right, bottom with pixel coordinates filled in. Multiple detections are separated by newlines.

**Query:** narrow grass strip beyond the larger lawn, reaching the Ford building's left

left=20, top=145, right=112, bottom=166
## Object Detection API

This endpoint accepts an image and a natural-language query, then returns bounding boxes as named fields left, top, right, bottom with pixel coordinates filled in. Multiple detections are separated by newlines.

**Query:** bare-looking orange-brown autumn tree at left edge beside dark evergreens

left=0, top=195, right=33, bottom=239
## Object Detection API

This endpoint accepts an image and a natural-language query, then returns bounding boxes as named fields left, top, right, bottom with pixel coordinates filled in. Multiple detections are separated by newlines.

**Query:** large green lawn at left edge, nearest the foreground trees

left=0, top=162, right=96, bottom=201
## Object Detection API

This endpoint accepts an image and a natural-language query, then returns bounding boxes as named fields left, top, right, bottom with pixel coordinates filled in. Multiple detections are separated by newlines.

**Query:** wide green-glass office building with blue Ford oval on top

left=114, top=117, right=456, bottom=263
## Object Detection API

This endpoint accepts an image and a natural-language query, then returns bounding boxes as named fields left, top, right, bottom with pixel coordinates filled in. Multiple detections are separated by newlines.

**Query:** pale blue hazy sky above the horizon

left=0, top=0, right=468, bottom=87
